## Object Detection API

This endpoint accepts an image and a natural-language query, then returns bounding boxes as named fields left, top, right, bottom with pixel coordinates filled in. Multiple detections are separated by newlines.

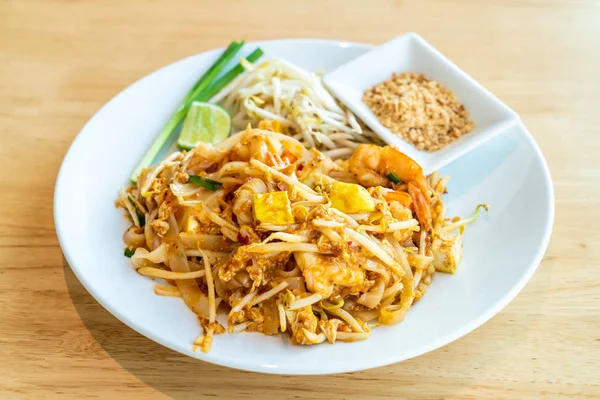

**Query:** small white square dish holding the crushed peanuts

left=323, top=33, right=519, bottom=174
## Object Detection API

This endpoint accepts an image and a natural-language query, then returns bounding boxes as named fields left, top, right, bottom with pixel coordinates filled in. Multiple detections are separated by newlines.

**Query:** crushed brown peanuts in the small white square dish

left=363, top=72, right=475, bottom=152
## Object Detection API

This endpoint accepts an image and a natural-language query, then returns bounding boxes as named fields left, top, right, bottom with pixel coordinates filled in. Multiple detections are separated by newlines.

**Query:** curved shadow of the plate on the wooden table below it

left=63, top=259, right=548, bottom=399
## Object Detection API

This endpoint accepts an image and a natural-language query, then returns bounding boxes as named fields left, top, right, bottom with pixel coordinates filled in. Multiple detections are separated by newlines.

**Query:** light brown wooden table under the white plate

left=0, top=0, right=600, bottom=400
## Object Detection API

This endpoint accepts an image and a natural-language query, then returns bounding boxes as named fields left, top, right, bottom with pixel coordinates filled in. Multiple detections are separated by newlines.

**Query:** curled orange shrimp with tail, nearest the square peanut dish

left=350, top=144, right=431, bottom=231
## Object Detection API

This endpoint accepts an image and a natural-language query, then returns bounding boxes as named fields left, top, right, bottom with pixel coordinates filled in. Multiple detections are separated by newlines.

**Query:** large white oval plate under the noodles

left=54, top=40, right=554, bottom=374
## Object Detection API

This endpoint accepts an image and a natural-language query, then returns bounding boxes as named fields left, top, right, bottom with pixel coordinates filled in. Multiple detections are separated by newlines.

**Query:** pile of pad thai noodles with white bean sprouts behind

left=117, top=42, right=488, bottom=352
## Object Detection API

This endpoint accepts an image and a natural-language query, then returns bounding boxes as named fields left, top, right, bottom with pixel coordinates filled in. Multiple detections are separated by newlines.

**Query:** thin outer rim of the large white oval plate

left=53, top=38, right=555, bottom=375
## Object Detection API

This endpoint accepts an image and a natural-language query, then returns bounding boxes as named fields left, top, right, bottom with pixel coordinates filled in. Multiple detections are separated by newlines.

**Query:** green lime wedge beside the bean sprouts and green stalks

left=177, top=101, right=231, bottom=150
